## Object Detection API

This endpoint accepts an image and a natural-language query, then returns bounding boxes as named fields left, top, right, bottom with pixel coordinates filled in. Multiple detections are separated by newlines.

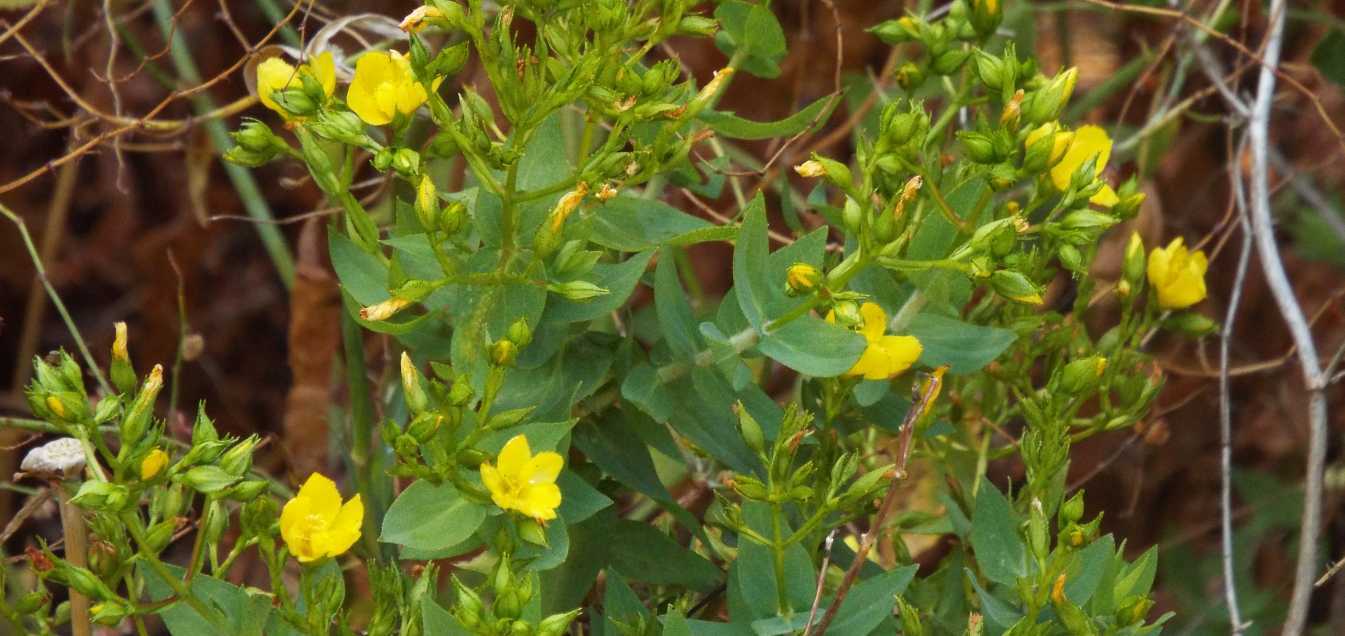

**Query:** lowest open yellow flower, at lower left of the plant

left=280, top=472, right=364, bottom=563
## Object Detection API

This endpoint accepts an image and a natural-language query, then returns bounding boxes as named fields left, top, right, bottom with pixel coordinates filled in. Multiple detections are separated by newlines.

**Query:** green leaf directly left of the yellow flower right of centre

left=757, top=316, right=865, bottom=378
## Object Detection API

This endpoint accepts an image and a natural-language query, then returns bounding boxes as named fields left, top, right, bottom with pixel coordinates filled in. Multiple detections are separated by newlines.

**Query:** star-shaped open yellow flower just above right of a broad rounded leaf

left=482, top=434, right=565, bottom=522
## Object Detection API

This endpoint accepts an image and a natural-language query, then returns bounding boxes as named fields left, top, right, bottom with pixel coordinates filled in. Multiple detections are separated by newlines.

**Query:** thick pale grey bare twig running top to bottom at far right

left=1248, top=0, right=1326, bottom=626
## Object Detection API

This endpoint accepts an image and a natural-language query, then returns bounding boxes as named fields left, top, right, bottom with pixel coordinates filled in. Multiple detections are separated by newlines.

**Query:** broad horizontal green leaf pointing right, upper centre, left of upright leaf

left=585, top=196, right=717, bottom=251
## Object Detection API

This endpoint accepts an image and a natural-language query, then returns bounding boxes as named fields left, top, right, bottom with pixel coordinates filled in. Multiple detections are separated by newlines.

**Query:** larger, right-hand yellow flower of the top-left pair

left=346, top=51, right=438, bottom=126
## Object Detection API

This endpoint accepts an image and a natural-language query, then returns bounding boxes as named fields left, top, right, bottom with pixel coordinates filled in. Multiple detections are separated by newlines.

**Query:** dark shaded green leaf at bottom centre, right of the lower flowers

left=605, top=519, right=720, bottom=592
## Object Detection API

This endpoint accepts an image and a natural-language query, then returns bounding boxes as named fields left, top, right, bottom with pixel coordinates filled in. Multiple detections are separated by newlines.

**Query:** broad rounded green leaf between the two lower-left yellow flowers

left=378, top=480, right=486, bottom=550
